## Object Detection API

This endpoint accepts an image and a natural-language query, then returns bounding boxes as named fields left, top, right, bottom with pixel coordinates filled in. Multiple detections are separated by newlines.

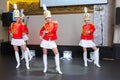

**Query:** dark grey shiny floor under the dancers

left=0, top=51, right=120, bottom=80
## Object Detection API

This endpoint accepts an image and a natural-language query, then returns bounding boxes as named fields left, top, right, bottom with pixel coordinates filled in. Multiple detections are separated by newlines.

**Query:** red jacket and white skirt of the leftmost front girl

left=8, top=22, right=25, bottom=46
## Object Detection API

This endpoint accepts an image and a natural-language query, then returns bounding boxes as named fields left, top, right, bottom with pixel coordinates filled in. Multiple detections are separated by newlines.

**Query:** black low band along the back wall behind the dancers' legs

left=1, top=42, right=115, bottom=59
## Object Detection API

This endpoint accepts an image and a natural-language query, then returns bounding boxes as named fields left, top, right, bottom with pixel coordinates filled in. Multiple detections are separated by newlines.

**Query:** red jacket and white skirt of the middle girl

left=39, top=21, right=58, bottom=49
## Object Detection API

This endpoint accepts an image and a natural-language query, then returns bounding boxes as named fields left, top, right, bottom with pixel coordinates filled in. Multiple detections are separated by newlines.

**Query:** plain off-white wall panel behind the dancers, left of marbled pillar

left=25, top=14, right=93, bottom=45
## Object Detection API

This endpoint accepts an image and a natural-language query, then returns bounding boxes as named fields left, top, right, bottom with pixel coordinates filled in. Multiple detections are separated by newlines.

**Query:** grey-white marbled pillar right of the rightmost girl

left=94, top=0, right=115, bottom=46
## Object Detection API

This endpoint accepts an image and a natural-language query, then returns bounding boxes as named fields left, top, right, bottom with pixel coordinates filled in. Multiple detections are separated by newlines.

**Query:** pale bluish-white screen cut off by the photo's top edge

left=40, top=0, right=108, bottom=6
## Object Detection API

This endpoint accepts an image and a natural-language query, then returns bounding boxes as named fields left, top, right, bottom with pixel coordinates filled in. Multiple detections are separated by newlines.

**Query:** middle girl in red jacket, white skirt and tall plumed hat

left=39, top=5, right=62, bottom=74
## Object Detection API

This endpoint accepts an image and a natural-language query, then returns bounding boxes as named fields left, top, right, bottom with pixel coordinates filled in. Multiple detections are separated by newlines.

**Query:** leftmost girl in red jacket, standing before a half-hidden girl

left=9, top=4, right=30, bottom=69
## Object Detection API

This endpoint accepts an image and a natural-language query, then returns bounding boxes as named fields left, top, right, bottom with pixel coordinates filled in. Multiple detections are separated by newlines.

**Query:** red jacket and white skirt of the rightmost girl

left=79, top=24, right=95, bottom=47
